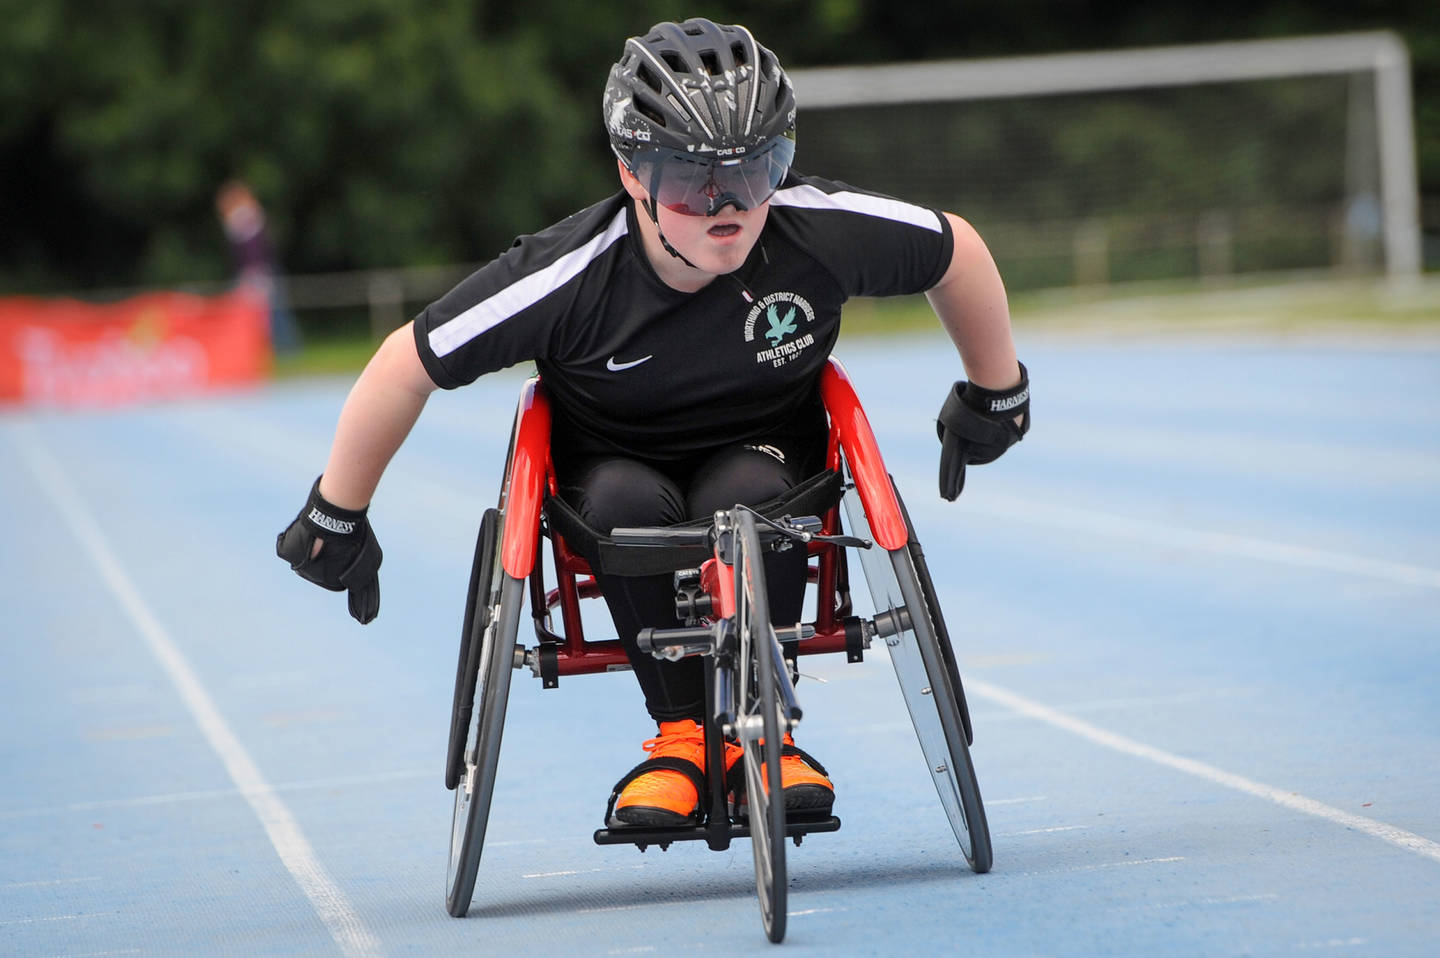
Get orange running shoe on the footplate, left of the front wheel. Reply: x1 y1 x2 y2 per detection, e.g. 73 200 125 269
605 719 740 828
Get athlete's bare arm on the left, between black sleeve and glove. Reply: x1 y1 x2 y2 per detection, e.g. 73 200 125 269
320 323 436 509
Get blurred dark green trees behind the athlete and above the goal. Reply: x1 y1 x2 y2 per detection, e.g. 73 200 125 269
0 0 1440 292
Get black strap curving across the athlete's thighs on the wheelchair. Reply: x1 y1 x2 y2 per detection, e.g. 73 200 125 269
544 470 841 576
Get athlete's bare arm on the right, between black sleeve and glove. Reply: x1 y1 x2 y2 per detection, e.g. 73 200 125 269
924 213 1020 389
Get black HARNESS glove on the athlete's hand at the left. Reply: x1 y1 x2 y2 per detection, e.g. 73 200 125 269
275 478 383 625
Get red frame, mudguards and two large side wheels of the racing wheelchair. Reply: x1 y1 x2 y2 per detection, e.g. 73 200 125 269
446 352 992 916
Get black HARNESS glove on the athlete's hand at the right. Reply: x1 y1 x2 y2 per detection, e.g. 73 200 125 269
935 363 1030 501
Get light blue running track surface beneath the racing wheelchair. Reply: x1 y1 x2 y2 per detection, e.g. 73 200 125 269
0 330 1440 958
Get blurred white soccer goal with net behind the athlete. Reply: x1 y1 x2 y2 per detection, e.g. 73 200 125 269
791 32 1421 287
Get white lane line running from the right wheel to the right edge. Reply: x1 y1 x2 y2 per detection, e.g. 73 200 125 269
965 679 1440 861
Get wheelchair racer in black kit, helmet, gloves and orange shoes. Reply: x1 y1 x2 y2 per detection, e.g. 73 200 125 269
276 19 1030 827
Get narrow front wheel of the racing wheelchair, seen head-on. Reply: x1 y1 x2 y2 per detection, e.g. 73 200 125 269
733 510 788 942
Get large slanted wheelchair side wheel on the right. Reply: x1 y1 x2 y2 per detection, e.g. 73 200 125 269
844 488 994 872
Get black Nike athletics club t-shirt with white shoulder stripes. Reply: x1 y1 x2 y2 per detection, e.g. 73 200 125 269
415 173 953 461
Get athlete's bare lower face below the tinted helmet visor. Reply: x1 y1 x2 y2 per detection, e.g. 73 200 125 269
619 157 770 285
